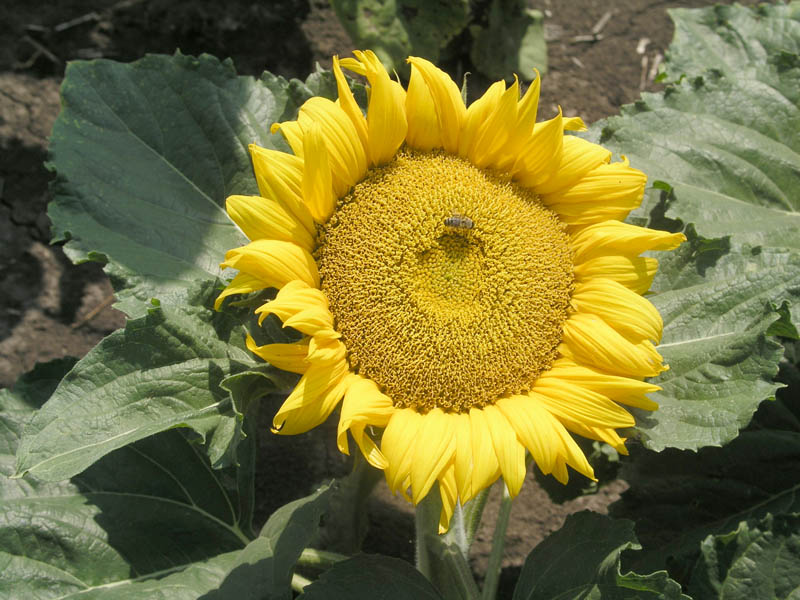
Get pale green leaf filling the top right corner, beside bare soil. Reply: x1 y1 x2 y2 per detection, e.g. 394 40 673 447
665 2 800 78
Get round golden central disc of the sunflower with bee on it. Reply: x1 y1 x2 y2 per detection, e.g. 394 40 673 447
315 150 573 412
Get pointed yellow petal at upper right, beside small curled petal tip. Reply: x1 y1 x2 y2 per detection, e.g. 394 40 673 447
512 108 564 189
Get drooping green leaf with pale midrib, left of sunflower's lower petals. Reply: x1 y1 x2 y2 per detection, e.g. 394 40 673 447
17 282 286 481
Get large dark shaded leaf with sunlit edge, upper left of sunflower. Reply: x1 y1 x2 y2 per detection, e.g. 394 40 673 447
48 54 335 316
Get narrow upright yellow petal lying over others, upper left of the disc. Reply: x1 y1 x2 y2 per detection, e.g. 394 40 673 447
303 122 336 224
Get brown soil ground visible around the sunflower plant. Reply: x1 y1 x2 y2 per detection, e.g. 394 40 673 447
0 0 754 597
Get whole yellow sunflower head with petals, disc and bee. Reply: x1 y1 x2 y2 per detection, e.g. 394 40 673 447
217 51 685 530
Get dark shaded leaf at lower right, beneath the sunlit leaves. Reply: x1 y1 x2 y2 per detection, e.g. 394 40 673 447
611 354 800 580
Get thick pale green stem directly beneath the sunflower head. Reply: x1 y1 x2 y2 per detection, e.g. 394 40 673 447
415 488 480 600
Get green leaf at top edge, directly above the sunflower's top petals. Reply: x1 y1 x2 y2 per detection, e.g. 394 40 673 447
331 0 470 75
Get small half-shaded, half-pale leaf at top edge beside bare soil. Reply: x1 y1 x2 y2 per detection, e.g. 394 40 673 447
470 0 547 81
